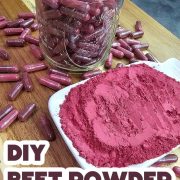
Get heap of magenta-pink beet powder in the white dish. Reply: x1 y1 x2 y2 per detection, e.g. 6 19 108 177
60 65 180 167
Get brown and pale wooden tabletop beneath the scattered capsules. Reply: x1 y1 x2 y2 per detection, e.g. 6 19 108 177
0 0 180 177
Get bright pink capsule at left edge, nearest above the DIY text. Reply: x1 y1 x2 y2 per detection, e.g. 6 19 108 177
0 109 19 132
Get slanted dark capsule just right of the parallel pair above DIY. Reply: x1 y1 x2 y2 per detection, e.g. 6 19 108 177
18 103 36 122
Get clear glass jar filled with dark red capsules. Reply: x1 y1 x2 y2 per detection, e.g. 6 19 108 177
36 0 123 72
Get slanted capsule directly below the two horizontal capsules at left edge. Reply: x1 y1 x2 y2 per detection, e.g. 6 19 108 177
8 81 24 101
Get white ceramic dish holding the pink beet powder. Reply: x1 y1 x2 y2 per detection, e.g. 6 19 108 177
49 59 180 169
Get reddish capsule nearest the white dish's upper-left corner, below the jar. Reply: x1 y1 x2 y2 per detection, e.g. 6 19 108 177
38 77 62 91
